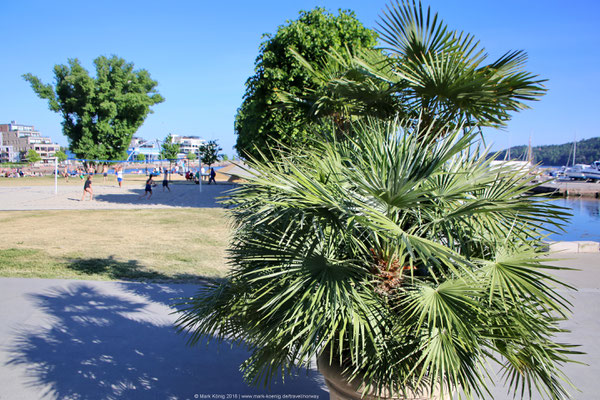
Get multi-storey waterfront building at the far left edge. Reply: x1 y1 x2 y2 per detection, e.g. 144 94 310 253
0 121 60 163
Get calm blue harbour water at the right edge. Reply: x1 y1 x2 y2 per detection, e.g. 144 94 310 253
549 199 600 242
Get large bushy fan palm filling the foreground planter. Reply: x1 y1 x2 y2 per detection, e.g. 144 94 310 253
178 119 573 399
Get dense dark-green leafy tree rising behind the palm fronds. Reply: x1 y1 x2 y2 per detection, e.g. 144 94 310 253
235 8 376 156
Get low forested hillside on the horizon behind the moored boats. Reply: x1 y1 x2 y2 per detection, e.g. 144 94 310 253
497 137 600 166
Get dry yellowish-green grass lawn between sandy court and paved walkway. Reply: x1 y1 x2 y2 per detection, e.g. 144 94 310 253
0 208 230 281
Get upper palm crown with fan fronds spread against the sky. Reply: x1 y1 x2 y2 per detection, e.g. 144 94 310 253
280 0 545 139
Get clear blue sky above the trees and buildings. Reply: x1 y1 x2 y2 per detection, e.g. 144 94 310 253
0 0 600 154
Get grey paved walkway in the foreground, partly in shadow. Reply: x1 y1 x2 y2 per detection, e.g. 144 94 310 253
0 253 600 400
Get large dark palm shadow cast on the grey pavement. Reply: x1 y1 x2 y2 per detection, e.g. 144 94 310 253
5 282 327 399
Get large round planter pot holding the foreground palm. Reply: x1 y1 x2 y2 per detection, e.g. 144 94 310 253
317 354 452 400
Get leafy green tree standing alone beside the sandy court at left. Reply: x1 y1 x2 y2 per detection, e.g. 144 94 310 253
23 56 164 164
